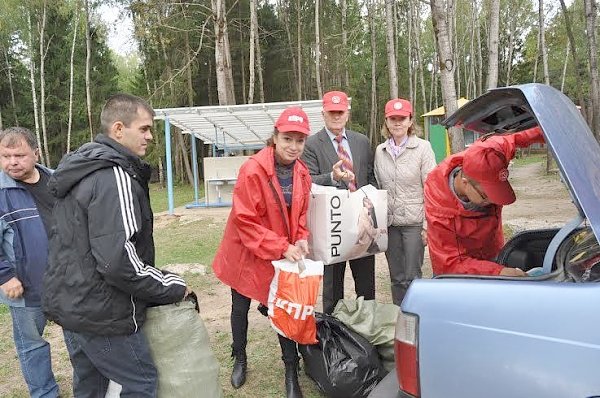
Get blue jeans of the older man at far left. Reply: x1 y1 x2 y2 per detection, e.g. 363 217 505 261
9 307 58 398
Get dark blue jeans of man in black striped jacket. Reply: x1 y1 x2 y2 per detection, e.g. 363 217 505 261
64 330 158 398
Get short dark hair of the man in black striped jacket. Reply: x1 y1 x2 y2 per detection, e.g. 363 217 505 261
100 93 156 134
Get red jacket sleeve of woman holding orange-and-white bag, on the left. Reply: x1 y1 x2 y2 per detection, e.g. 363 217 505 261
231 168 289 260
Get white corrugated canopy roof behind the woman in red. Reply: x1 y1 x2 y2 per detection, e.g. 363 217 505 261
155 100 324 149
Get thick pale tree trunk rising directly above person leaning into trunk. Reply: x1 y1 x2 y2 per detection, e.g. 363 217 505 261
430 0 465 153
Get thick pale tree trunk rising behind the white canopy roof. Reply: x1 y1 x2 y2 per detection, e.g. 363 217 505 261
211 0 235 105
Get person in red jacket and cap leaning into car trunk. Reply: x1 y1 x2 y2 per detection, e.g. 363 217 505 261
424 127 544 276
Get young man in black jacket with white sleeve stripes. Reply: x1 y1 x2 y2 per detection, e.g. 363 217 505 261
43 94 190 398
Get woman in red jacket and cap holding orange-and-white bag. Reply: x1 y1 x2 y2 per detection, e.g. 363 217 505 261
213 107 311 398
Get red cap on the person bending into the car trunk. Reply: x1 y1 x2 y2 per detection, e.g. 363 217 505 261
462 141 516 205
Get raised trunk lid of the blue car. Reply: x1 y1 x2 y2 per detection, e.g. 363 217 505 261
442 83 600 243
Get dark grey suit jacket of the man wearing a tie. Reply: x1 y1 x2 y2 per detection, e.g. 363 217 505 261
302 129 377 189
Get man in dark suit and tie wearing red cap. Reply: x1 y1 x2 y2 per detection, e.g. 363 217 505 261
302 91 377 314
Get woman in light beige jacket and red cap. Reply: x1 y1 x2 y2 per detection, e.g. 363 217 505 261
375 98 436 306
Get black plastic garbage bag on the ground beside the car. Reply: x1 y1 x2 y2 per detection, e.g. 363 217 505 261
299 313 386 398
